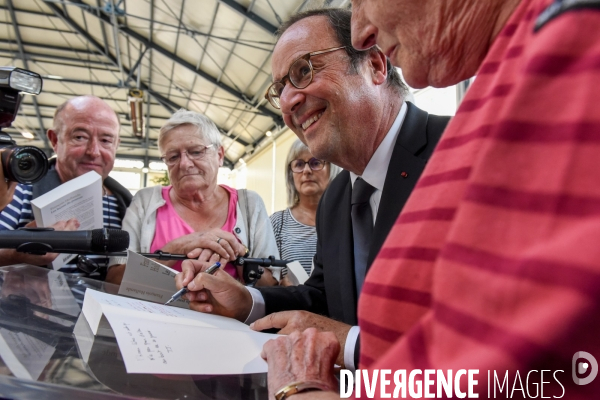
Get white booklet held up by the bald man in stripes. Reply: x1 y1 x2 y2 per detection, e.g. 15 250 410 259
31 171 104 270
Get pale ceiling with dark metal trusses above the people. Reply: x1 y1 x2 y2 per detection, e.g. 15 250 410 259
0 0 349 166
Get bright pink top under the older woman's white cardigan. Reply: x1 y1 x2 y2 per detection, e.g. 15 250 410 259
150 185 238 278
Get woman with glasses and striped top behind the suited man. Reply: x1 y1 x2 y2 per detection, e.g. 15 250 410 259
271 139 340 275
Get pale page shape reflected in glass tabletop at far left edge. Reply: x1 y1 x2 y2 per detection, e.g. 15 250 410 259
0 328 55 381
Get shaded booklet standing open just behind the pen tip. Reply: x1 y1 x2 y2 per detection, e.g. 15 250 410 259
119 250 189 308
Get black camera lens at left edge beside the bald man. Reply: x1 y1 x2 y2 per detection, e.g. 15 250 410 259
2 146 48 184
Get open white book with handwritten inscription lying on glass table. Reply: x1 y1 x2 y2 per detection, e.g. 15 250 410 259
82 289 277 375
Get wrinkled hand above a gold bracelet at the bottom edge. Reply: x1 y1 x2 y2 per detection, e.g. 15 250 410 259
261 328 340 399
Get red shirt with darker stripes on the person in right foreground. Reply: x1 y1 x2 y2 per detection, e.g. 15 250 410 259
358 0 600 399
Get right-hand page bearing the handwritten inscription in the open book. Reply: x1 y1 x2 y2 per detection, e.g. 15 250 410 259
107 314 270 375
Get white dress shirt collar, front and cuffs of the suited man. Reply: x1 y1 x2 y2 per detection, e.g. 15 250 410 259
244 103 408 370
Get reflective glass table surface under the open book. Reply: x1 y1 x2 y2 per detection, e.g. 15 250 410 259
0 265 268 400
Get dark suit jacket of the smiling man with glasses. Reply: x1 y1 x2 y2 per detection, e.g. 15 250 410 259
259 102 450 325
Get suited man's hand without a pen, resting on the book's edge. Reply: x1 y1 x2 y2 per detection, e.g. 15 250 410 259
250 311 352 367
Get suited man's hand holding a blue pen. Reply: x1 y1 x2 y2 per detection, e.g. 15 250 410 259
175 260 252 321
